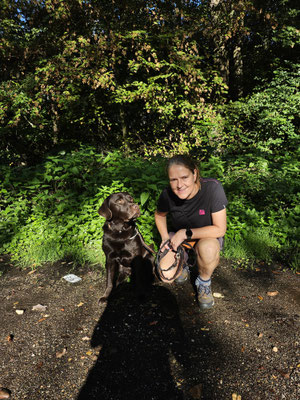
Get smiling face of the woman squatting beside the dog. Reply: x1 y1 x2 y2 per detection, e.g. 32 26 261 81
168 164 199 200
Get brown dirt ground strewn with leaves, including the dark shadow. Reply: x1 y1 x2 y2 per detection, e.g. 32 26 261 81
0 258 300 400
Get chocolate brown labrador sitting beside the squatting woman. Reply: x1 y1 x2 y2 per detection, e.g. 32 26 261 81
98 192 154 302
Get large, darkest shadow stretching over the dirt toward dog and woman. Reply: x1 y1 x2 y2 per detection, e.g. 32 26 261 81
77 284 189 400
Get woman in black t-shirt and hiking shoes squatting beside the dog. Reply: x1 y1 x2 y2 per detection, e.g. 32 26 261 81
155 155 228 310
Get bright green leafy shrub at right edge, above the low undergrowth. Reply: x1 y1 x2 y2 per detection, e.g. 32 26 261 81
225 64 300 155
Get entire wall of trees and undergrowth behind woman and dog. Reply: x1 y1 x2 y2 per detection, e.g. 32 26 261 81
0 0 300 270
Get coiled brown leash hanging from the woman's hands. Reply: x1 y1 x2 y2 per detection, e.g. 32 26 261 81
155 239 195 282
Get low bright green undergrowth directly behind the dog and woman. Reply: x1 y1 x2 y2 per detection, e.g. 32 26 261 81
0 147 299 270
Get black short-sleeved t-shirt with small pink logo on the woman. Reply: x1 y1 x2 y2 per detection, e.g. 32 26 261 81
157 178 228 232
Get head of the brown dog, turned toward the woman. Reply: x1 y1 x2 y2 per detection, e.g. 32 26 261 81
98 192 141 222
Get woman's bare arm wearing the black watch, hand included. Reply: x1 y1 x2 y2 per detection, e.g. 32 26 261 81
171 208 227 250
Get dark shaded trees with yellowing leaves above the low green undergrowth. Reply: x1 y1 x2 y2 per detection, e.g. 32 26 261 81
0 0 299 165
